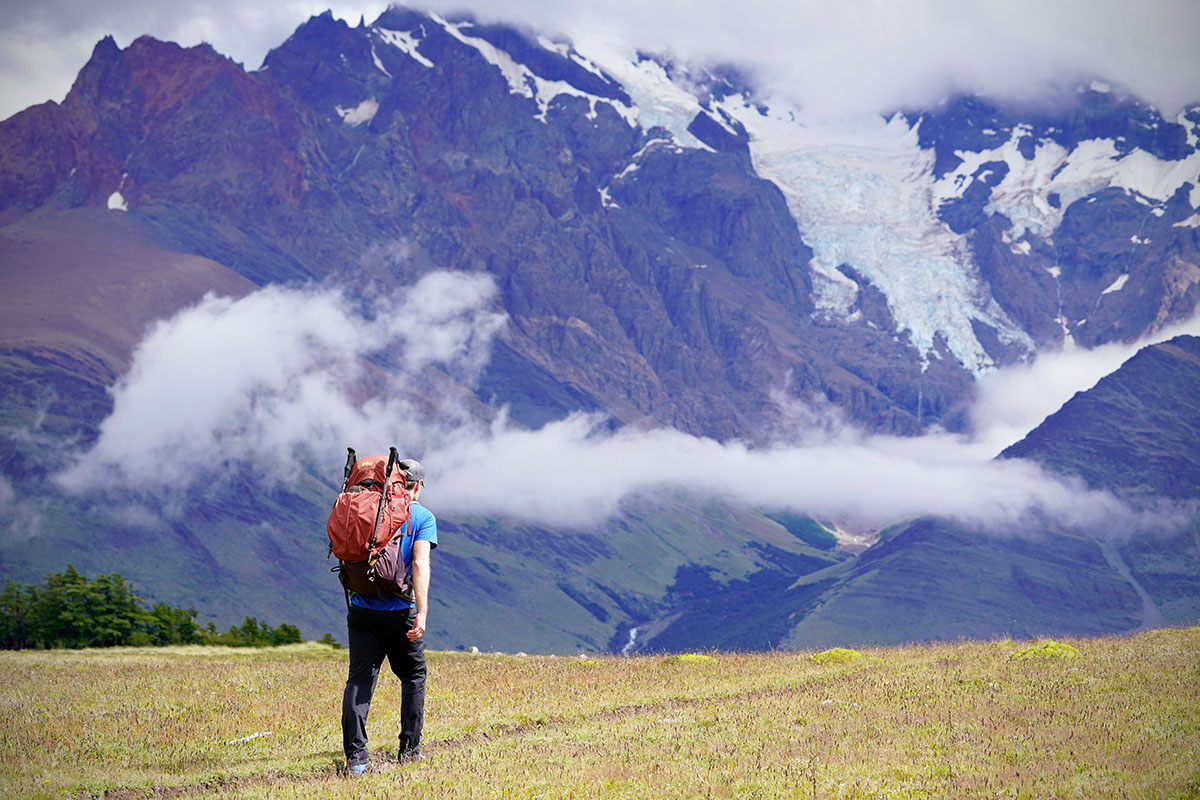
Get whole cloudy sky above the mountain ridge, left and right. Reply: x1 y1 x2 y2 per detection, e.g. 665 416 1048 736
0 0 1200 119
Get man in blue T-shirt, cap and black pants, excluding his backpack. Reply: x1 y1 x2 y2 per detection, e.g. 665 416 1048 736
342 458 438 775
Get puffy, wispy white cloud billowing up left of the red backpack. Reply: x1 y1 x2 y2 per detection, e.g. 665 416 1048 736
64 272 505 489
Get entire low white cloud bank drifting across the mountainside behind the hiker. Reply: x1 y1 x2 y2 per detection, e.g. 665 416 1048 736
56 272 1196 537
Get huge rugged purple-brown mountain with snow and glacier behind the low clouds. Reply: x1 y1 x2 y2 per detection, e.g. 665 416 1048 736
0 7 1200 650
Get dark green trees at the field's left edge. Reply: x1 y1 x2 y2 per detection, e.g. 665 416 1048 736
0 565 307 650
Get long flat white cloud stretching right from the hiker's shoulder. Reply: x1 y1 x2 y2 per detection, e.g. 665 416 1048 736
426 407 1128 529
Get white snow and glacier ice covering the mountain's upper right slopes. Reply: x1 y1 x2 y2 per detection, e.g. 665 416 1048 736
443 20 1200 374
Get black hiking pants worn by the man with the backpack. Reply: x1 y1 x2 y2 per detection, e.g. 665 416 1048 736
342 604 425 764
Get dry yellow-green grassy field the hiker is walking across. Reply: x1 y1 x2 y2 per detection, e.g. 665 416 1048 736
0 627 1200 800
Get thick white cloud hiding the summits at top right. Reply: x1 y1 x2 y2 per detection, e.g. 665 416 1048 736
428 0 1200 115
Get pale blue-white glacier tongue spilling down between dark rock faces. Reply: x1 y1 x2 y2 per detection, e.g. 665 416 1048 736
720 96 1034 374
